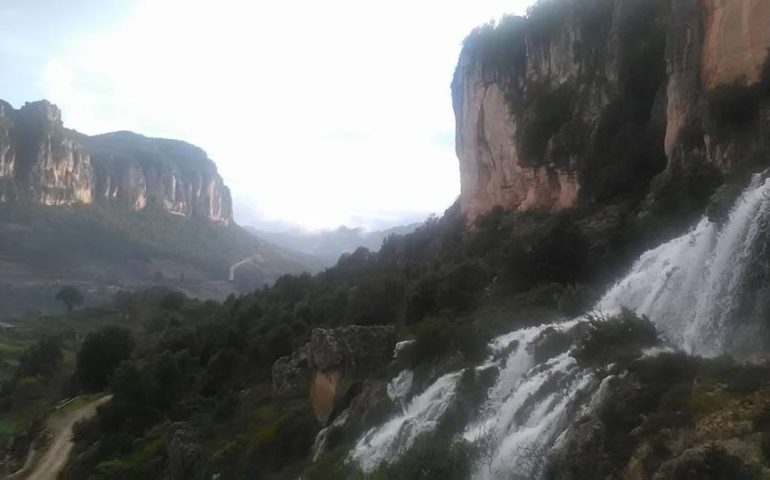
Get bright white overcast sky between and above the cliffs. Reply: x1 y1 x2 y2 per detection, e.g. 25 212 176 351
0 0 531 229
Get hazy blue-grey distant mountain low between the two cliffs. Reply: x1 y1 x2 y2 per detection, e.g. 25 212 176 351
246 223 421 265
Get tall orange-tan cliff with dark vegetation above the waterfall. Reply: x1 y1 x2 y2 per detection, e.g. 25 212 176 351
452 0 770 220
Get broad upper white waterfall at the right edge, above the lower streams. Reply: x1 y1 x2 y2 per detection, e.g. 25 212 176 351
597 175 770 356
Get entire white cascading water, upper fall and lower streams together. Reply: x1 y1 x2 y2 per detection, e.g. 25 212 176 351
350 175 770 480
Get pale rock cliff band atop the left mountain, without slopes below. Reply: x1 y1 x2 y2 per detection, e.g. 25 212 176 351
0 101 232 224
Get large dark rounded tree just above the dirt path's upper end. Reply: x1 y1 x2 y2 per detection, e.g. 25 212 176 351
76 325 134 391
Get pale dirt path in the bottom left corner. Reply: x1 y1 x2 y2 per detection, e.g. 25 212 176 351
8 395 112 480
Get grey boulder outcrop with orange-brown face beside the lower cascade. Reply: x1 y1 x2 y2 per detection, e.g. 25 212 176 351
273 325 396 425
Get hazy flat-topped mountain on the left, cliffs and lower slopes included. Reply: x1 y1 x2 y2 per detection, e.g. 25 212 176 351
0 101 321 316
